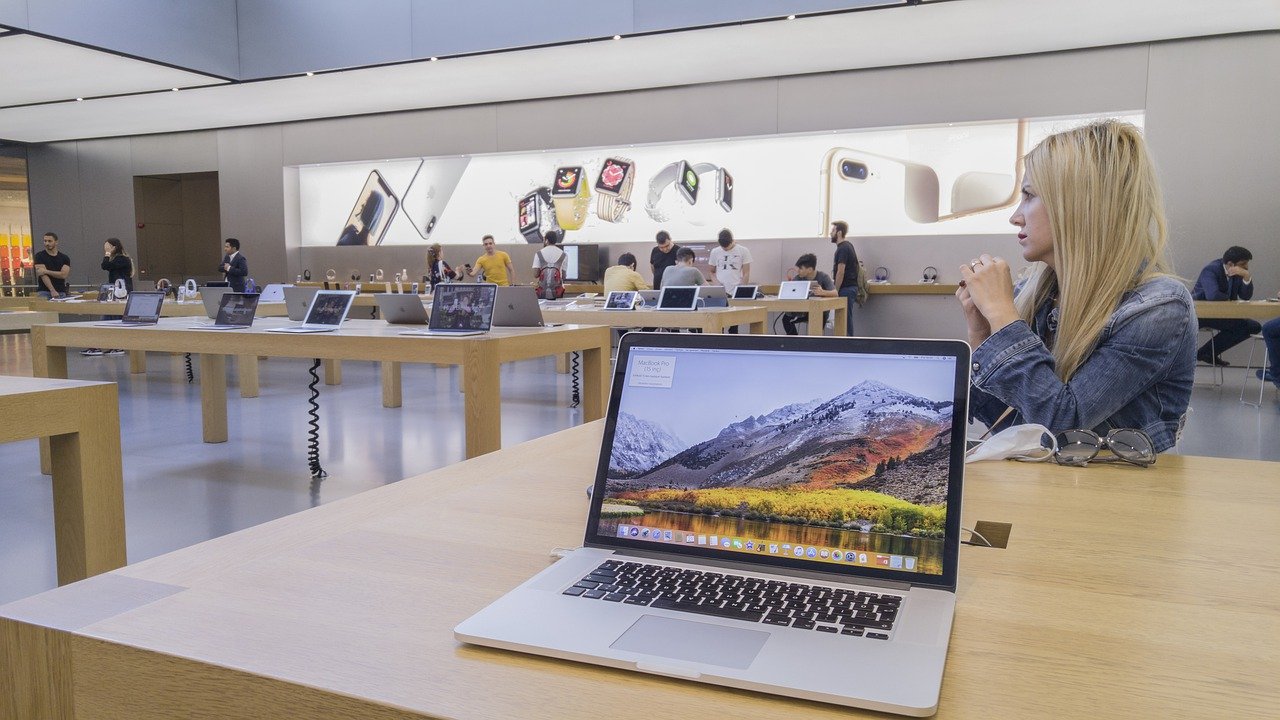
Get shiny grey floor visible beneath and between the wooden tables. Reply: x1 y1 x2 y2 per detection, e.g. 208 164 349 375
0 334 1280 603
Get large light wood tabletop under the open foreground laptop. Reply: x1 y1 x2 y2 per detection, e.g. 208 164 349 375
0 423 1280 720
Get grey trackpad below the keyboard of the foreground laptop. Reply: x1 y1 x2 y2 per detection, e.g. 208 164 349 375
609 615 769 670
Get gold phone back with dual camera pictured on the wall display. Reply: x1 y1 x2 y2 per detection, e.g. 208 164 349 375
819 147 938 234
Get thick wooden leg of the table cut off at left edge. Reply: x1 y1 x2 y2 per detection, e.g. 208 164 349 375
50 386 127 585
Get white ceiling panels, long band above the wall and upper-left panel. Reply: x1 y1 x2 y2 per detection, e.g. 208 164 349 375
0 0 1280 142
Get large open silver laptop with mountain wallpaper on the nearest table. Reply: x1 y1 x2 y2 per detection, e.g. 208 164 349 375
454 333 969 716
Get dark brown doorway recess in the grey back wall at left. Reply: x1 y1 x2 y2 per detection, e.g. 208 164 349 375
133 173 223 284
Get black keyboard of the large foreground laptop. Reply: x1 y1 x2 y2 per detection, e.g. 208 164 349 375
564 560 902 641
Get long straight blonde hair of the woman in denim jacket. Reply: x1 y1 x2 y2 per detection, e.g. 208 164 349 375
1016 120 1170 382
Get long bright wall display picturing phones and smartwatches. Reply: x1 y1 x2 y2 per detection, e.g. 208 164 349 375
297 113 1143 246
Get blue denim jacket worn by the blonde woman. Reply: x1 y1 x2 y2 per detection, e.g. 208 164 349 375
969 271 1196 452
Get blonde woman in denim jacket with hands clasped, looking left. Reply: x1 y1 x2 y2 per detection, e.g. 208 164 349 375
956 120 1196 452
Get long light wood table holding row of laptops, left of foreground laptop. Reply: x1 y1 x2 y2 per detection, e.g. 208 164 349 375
31 318 609 457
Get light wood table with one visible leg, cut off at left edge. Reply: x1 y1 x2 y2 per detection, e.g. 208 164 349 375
0 375 125 586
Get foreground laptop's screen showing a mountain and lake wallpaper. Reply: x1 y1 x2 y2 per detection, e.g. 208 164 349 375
588 333 968 584
